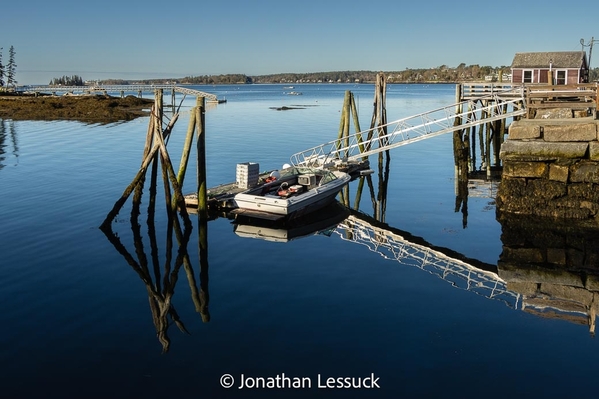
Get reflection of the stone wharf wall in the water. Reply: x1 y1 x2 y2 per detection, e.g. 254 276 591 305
498 215 599 336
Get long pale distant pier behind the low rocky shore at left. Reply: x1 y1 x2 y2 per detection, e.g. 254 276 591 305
18 84 217 101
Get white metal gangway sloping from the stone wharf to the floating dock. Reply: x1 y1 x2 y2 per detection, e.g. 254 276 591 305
290 86 526 166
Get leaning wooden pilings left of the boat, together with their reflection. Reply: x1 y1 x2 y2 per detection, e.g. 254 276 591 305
100 89 210 352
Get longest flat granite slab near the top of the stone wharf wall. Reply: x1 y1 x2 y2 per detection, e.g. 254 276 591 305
499 140 589 161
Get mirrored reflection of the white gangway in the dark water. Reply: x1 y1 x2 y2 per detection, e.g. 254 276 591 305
334 213 521 309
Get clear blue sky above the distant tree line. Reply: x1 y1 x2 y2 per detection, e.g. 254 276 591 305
0 0 599 84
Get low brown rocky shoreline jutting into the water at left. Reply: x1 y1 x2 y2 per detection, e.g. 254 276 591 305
0 93 154 124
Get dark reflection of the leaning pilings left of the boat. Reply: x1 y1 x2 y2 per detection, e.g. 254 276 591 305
100 198 210 353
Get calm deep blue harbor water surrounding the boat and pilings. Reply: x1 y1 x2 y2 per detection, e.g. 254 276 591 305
0 84 599 398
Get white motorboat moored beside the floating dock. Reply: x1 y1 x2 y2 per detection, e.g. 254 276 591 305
233 167 351 219
